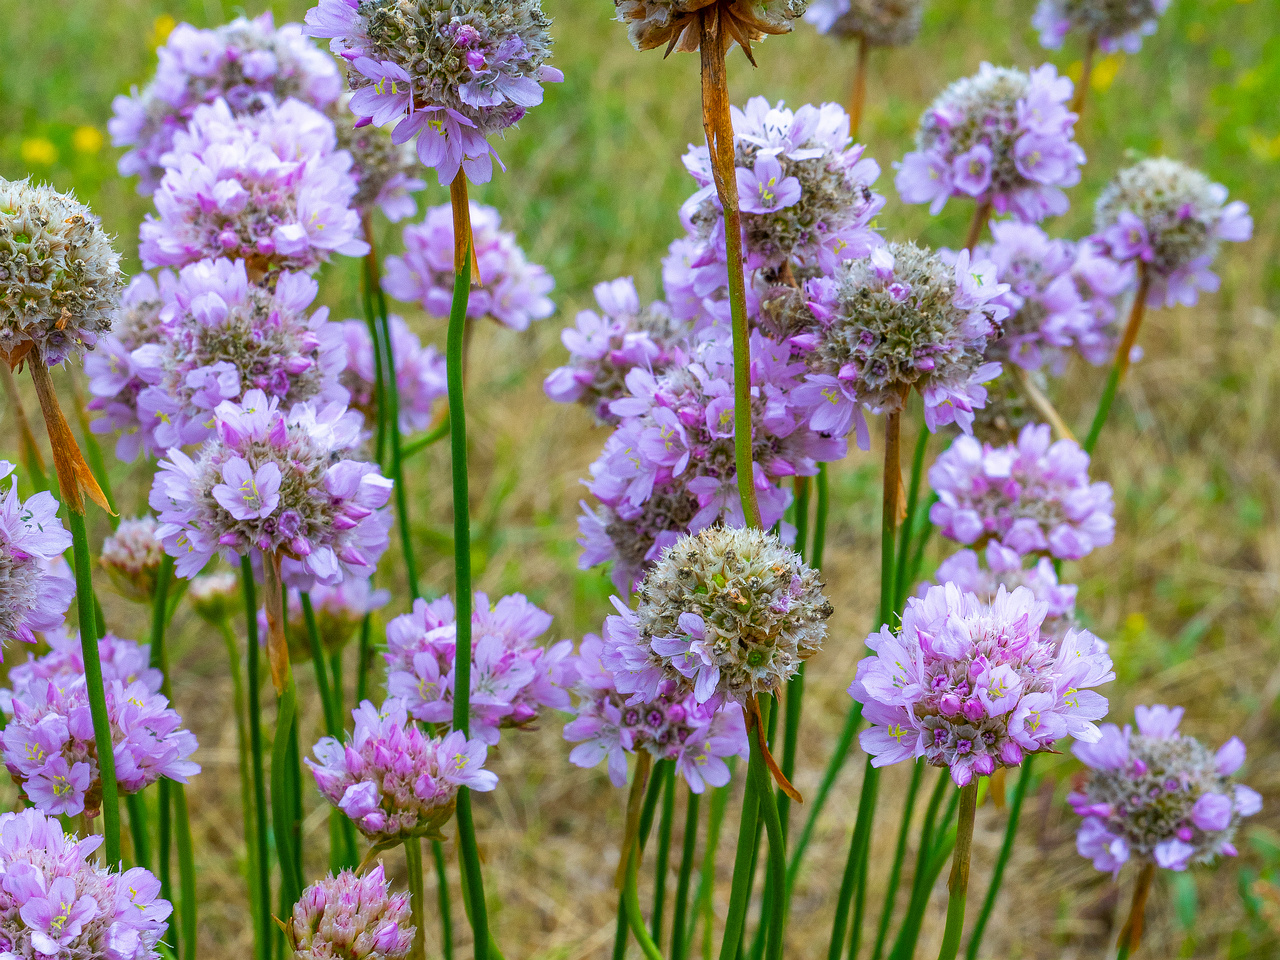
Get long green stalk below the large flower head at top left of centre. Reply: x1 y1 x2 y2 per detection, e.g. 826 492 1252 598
448 173 489 960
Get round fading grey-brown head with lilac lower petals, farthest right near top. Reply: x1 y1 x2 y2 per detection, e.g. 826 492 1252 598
1094 156 1253 306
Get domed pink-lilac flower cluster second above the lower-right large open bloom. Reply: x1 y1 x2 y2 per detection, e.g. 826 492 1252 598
929 424 1116 559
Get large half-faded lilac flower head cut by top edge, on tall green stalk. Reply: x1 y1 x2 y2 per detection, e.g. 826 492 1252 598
306 0 564 184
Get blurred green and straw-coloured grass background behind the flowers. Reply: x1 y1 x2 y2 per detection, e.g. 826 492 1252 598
0 0 1280 960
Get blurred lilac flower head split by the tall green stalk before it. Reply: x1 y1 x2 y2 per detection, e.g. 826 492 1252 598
383 202 556 330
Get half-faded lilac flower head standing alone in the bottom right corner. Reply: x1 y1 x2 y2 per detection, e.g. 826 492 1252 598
1068 705 1262 873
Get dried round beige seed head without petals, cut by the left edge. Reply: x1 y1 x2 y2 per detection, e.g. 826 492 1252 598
0 178 124 366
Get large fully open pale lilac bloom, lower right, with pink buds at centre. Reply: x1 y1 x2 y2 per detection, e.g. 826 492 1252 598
849 584 1115 786
